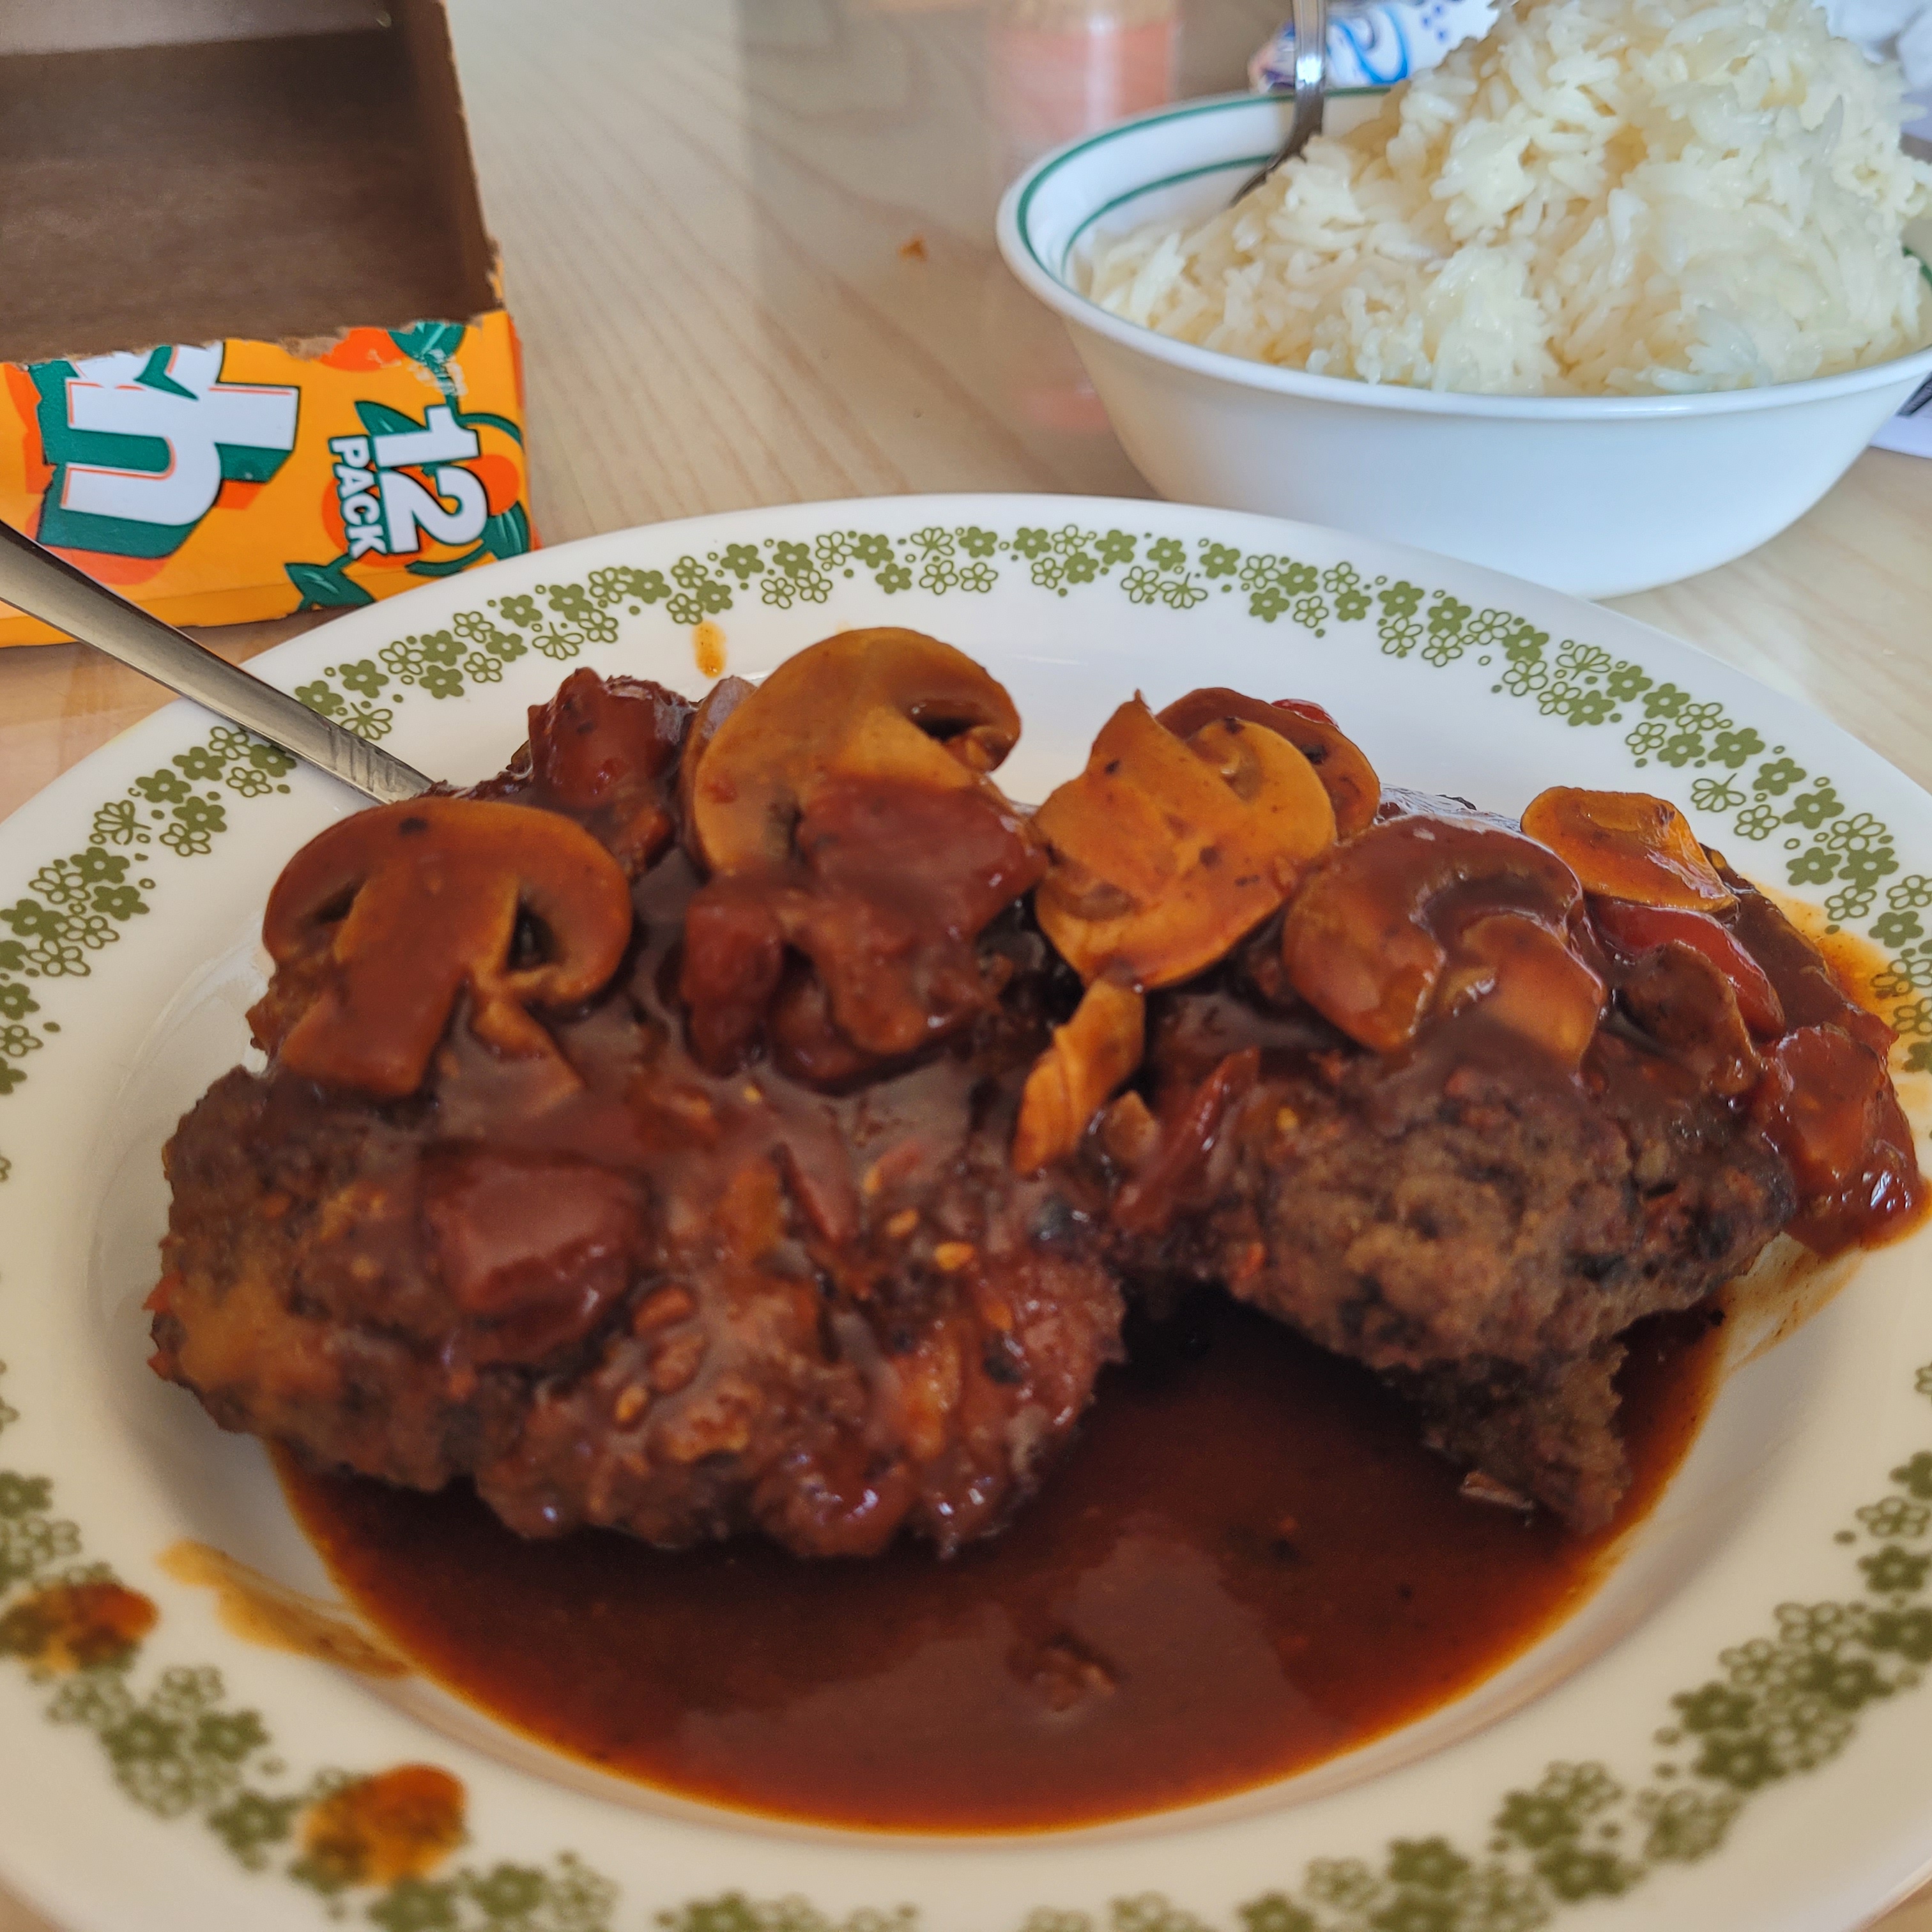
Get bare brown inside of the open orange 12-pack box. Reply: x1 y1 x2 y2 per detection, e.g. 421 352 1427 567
0 0 496 361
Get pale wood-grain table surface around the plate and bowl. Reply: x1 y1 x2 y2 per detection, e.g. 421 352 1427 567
0 0 1932 1932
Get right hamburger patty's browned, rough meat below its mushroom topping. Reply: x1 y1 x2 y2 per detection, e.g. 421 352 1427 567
1124 946 1797 1528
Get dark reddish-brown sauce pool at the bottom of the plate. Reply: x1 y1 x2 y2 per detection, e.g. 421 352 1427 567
278 1296 1721 1832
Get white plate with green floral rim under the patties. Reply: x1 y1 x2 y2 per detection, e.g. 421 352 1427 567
0 496 1932 1932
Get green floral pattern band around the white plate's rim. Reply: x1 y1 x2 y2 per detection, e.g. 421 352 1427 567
0 524 1932 1932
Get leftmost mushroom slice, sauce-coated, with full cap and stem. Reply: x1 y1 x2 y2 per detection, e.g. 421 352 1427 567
263 798 632 1100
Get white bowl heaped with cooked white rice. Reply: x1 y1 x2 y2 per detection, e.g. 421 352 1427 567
999 0 1932 597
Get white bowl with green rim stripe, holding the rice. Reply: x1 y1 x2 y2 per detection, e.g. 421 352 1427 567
999 95 1932 597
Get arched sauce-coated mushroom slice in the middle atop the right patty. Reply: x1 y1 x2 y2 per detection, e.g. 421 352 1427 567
1281 813 1583 1053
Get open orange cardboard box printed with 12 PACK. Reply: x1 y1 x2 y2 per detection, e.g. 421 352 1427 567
0 0 535 643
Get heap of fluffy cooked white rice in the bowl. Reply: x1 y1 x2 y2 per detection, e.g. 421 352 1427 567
1084 0 1932 396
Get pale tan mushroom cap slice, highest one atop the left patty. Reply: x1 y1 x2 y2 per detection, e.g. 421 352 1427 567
686 630 1020 873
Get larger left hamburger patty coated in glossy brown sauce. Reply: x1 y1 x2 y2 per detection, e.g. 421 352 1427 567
153 657 1121 1555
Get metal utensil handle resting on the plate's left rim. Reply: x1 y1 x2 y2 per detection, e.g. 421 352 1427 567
0 524 431 806
